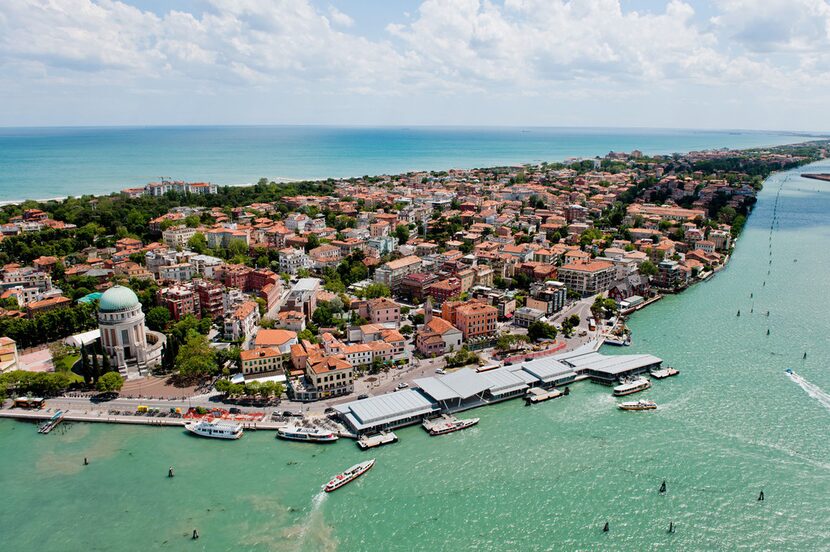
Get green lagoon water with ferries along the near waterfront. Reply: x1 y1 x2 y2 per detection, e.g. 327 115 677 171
0 128 830 552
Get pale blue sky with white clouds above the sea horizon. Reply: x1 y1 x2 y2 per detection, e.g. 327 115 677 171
0 0 830 132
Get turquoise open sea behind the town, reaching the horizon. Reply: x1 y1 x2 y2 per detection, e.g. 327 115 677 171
0 126 820 201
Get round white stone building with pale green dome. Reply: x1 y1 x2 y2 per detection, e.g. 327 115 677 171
98 286 165 379
